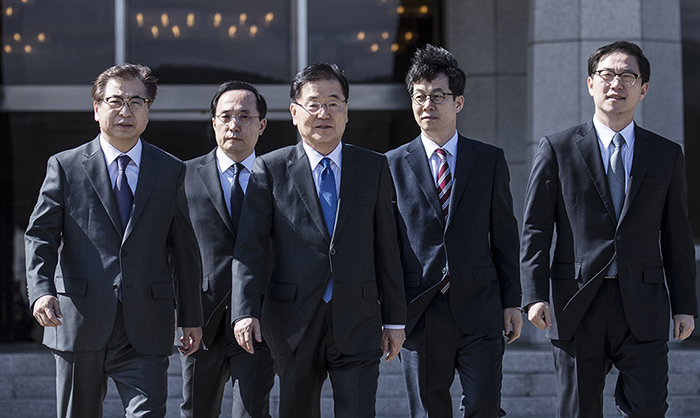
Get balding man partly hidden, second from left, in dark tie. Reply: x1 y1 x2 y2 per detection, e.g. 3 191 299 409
180 81 275 418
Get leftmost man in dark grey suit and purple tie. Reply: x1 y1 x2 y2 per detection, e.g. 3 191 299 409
25 64 202 418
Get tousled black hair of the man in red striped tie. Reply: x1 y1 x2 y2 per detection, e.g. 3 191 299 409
406 44 467 98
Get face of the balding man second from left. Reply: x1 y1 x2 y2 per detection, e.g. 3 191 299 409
211 90 267 163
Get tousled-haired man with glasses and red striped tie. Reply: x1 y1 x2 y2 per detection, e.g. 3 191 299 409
387 45 523 418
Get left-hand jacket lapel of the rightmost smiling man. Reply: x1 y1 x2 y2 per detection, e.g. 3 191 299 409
575 120 617 222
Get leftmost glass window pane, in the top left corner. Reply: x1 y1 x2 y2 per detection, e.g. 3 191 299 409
2 0 114 85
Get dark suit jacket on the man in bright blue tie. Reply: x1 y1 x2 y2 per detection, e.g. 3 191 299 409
231 142 406 354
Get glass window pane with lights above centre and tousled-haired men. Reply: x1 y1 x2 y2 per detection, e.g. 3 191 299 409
308 0 440 83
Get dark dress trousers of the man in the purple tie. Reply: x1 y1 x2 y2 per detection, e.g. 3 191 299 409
52 303 168 418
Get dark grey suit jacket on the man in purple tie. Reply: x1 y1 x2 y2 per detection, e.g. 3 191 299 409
25 137 202 356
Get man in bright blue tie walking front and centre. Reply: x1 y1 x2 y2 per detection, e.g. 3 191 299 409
231 64 406 418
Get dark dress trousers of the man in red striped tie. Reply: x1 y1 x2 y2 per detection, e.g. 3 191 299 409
401 294 505 418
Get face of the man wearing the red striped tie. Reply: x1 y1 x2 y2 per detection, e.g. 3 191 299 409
411 74 464 146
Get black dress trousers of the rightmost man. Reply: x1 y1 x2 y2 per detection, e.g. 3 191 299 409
552 279 668 418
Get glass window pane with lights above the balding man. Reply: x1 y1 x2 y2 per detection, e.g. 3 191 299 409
126 0 293 84
